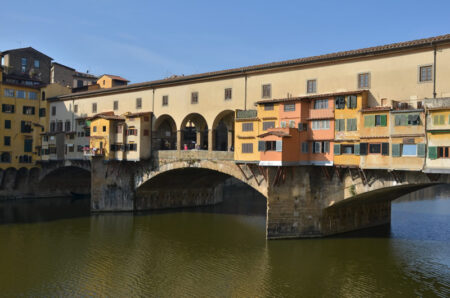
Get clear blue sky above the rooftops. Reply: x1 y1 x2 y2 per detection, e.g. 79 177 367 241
0 0 450 83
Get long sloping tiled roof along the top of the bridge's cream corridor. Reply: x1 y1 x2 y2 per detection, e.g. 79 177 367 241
52 34 450 100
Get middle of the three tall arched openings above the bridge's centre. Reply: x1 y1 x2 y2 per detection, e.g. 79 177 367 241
181 113 208 150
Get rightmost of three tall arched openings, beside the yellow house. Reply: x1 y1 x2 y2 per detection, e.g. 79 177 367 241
213 110 234 151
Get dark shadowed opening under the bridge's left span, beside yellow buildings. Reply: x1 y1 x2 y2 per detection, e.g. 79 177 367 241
37 166 91 196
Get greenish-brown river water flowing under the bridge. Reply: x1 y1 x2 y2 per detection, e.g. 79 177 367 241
0 185 450 297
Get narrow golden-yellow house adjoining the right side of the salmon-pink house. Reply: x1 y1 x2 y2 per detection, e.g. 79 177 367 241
333 90 368 167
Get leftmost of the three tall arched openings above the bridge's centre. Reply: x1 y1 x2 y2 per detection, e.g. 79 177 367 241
152 115 177 150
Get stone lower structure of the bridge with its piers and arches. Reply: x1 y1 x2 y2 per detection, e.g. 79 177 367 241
87 150 450 239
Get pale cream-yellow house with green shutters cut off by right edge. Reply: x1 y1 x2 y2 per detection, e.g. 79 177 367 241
425 98 450 174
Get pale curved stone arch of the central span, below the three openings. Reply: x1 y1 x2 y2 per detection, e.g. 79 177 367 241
134 160 268 199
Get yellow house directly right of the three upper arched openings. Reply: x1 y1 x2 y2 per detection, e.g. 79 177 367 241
234 110 260 163
